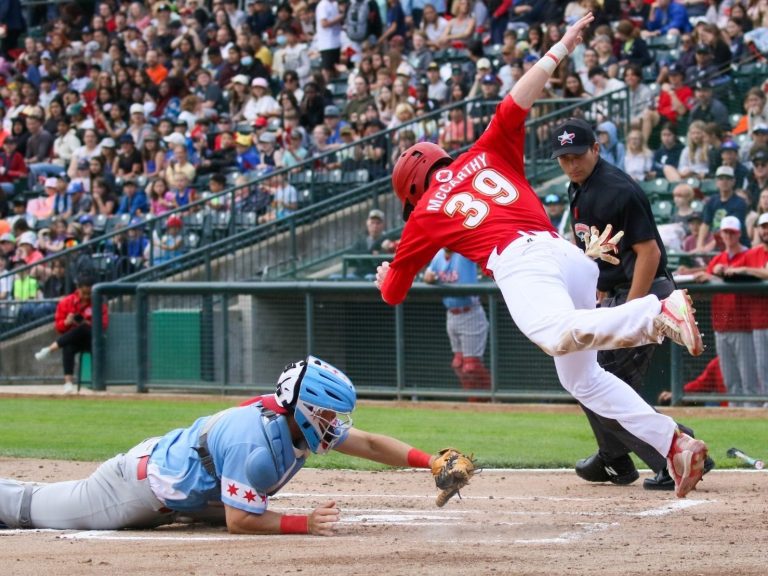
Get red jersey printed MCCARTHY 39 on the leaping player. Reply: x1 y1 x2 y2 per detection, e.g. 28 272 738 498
381 96 555 305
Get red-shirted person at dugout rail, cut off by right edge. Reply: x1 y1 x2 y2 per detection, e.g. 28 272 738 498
725 213 768 407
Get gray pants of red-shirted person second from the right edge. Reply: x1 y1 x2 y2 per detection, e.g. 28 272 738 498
715 332 765 407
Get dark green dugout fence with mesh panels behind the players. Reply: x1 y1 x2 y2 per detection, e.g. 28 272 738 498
84 282 768 403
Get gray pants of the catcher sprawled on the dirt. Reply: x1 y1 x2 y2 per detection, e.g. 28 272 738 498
0 439 175 530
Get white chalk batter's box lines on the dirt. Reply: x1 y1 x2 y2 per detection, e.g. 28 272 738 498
0 494 717 545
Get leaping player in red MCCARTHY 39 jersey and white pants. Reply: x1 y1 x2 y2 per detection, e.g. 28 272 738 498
376 14 707 497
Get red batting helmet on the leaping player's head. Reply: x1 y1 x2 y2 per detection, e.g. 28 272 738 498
392 142 453 220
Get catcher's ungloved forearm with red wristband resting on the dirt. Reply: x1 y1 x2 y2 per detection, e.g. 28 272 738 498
224 502 339 536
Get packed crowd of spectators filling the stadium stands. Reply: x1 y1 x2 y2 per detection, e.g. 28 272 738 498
0 0 768 328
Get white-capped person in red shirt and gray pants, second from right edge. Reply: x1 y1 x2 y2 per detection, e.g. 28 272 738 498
694 216 761 407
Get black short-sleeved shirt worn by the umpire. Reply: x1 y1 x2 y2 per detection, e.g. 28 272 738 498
568 158 667 292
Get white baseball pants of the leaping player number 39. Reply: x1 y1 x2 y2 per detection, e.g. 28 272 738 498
488 232 676 457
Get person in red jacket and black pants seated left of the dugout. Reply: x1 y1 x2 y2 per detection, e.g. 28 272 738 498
35 275 109 394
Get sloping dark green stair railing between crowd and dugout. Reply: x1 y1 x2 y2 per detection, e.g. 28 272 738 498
0 90 627 340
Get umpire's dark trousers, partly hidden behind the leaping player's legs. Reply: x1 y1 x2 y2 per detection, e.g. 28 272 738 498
581 278 693 472
